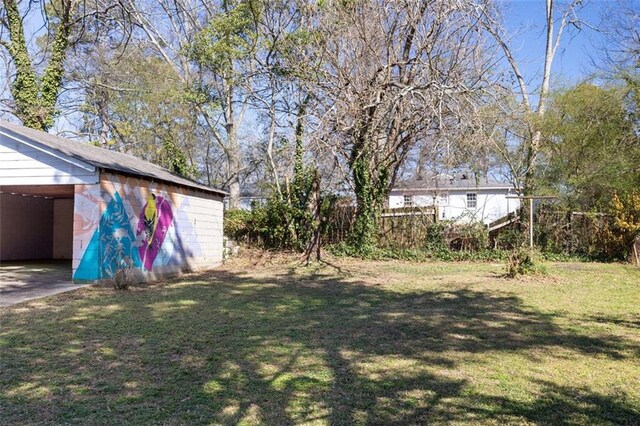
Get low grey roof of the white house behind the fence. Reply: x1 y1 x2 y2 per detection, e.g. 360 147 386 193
391 173 515 192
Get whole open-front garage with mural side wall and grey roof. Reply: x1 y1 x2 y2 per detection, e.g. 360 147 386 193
0 120 226 282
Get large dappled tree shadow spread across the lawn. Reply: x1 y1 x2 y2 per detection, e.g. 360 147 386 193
0 271 637 425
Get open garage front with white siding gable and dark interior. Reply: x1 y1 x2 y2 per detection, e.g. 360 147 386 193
0 128 99 290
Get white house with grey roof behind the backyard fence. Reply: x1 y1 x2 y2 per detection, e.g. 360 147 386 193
389 173 520 224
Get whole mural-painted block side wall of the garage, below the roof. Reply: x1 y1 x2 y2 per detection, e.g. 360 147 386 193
74 173 223 280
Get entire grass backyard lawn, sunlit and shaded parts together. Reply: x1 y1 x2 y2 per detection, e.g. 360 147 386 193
0 258 640 425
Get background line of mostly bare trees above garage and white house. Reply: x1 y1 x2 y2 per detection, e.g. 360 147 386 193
0 0 640 255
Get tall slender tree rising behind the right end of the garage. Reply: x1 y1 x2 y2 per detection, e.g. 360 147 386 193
108 0 260 208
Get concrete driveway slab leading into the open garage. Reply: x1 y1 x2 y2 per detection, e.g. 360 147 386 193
0 261 88 308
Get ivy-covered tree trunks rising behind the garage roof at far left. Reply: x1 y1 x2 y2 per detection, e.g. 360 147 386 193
0 0 127 130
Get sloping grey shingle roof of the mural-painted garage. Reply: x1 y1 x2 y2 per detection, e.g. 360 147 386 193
0 120 227 196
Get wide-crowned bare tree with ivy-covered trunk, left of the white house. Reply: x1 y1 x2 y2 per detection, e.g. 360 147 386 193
310 0 490 250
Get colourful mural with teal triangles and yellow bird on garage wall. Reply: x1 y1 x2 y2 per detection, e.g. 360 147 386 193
73 176 202 280
